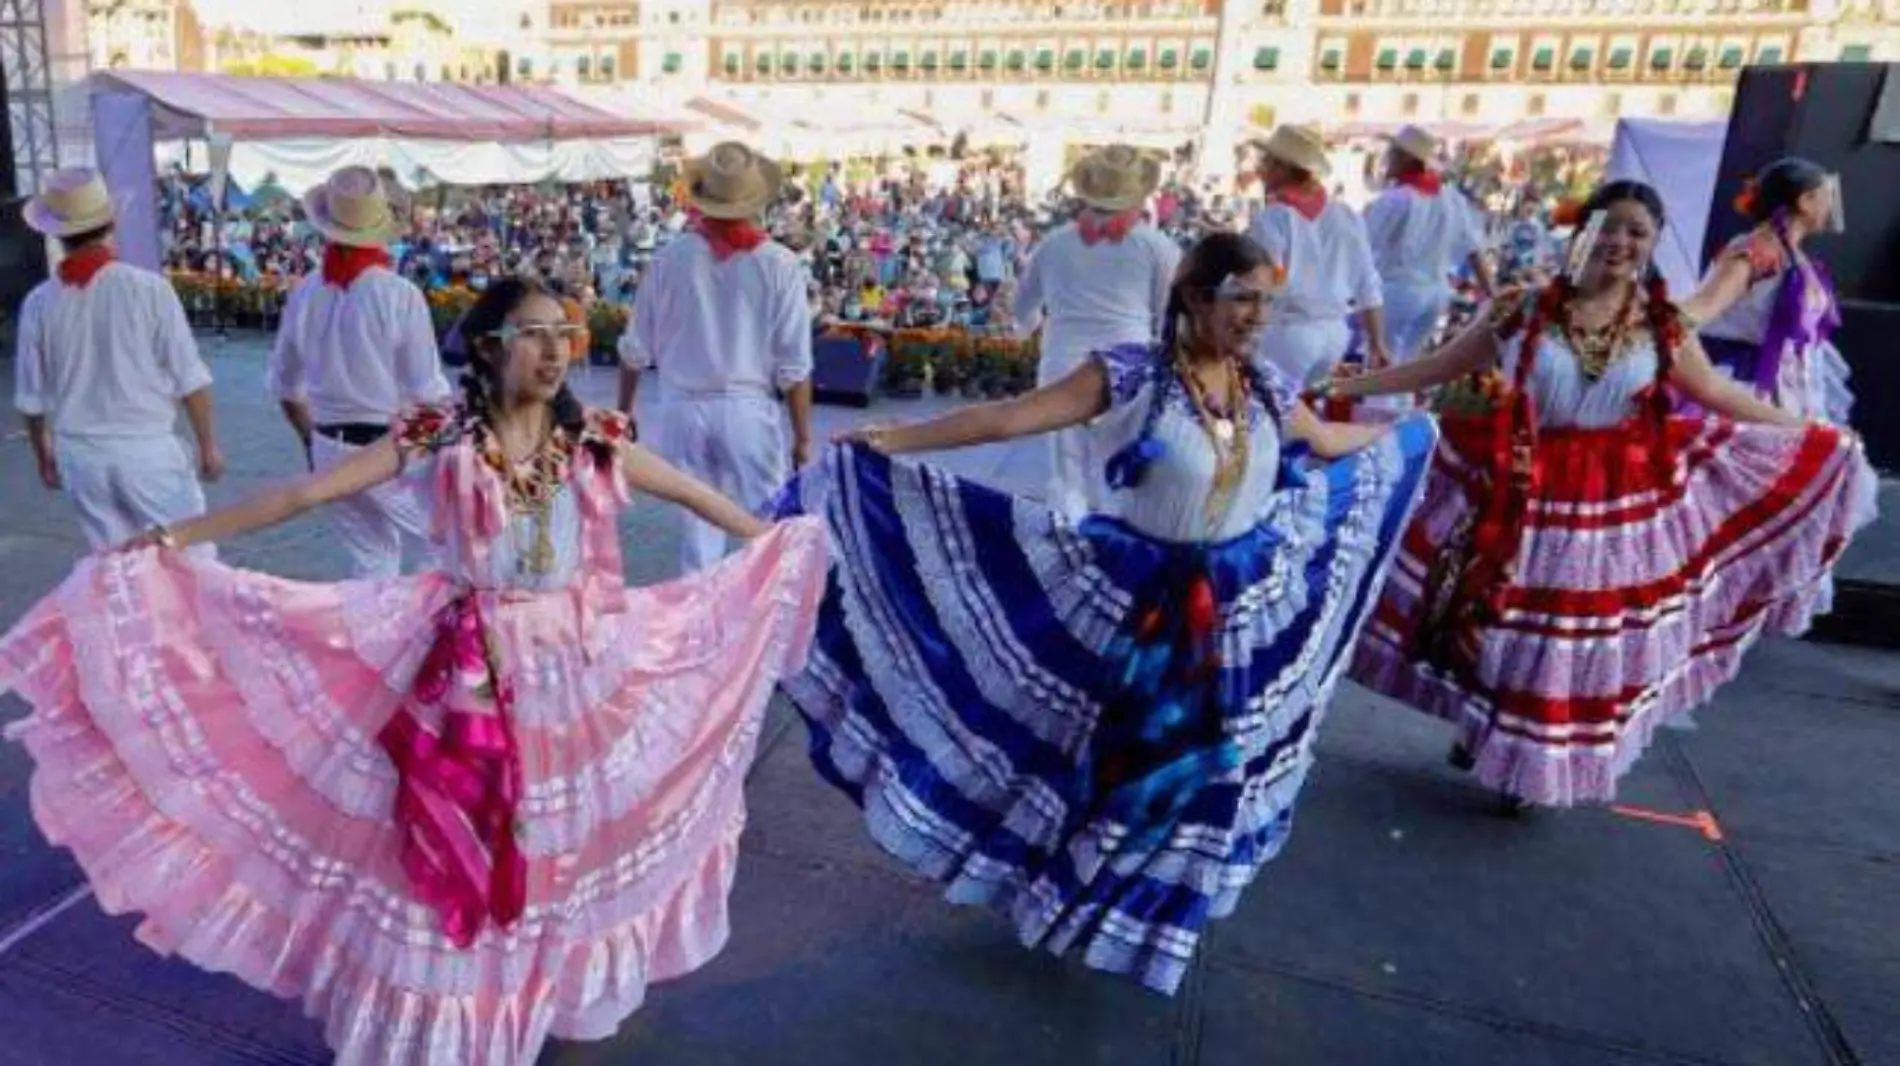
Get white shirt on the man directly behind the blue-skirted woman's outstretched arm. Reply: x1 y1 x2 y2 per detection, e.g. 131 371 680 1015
1013 222 1182 359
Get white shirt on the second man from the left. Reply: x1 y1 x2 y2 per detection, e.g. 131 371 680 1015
266 266 450 426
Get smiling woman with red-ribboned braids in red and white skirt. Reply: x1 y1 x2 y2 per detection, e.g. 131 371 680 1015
1330 182 1875 806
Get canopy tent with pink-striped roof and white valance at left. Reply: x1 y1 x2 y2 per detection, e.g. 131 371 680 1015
89 70 680 270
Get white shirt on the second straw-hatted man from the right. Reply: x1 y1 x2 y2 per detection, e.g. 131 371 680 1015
1248 200 1385 323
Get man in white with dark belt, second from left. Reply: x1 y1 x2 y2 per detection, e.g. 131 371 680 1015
268 167 452 578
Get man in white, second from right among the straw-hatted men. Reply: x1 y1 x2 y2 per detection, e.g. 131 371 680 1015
1248 125 1387 388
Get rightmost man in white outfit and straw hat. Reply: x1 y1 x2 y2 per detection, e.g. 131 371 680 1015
1366 125 1492 363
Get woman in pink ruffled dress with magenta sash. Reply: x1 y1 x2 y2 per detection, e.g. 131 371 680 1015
0 279 827 1066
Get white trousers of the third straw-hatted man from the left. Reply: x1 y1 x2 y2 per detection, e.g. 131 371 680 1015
654 390 792 574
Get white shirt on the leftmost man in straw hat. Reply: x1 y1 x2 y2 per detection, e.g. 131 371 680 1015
13 262 211 439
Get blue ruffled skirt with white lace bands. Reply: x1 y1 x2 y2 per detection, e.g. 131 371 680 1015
775 416 1436 994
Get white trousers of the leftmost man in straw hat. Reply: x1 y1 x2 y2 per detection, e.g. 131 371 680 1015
53 435 217 559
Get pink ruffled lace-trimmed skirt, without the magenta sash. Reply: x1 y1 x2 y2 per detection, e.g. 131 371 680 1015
0 519 827 1066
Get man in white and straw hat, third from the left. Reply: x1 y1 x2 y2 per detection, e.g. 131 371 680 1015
619 143 811 572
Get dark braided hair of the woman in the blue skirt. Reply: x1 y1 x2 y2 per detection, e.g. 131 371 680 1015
1108 232 1286 488
